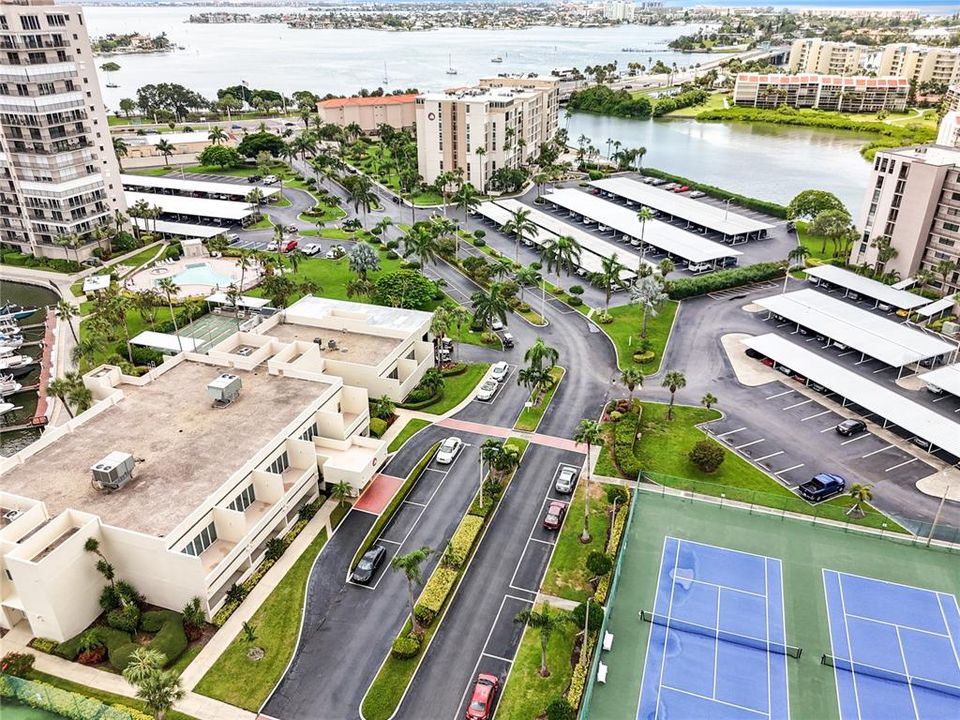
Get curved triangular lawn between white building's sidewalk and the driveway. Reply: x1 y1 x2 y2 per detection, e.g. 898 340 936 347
195 529 327 712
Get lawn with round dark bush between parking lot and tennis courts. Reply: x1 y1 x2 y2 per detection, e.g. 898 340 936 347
597 402 903 531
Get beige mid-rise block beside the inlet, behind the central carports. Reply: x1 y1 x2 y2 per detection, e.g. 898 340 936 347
417 77 560 190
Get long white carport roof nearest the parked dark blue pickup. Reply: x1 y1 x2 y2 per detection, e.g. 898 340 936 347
744 333 960 457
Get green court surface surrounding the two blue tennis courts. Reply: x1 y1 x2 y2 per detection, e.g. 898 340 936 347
582 490 960 720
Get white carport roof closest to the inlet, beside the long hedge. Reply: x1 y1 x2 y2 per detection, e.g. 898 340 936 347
590 177 773 235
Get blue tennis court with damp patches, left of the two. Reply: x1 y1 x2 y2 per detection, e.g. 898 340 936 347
637 537 789 720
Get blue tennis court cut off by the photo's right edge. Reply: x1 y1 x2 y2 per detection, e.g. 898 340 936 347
823 570 960 720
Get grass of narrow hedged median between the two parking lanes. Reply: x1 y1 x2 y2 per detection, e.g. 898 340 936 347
360 437 529 720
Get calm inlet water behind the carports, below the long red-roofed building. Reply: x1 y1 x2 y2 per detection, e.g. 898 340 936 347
567 113 870 208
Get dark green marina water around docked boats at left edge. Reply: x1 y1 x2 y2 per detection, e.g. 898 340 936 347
0 280 58 456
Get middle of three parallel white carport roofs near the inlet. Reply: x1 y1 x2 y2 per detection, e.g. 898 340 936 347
543 188 743 263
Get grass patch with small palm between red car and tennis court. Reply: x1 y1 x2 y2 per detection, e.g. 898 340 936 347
497 606 579 720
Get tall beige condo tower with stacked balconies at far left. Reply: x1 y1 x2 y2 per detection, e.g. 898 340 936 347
0 0 126 259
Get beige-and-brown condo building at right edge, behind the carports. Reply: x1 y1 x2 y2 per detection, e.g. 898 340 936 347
850 145 960 293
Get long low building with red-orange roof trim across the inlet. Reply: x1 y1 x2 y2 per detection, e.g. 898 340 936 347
733 73 910 112
